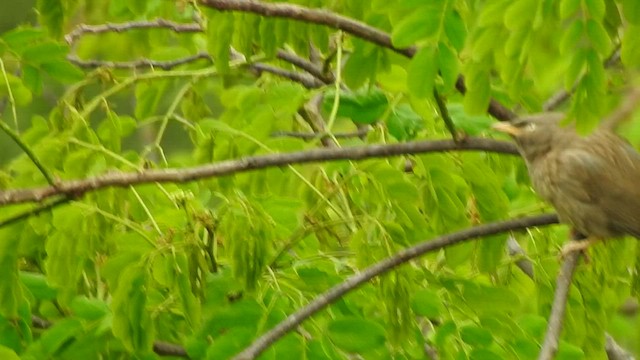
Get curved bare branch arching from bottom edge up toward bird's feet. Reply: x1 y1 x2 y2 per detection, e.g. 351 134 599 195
234 214 558 360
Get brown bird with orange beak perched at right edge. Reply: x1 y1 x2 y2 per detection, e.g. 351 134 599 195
494 111 640 254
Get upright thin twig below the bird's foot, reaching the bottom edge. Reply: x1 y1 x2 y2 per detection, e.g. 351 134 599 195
538 251 581 360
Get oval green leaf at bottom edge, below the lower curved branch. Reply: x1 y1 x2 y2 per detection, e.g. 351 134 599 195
327 317 386 353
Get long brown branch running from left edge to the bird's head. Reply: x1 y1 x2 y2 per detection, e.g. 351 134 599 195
0 138 518 205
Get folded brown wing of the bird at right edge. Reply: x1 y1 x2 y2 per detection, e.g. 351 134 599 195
557 143 640 238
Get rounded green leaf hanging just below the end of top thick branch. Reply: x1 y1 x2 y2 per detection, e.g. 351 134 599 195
407 46 438 98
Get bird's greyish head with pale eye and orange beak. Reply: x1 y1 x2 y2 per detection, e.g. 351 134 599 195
493 113 578 162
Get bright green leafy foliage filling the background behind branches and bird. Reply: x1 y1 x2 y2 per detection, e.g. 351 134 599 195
0 0 640 359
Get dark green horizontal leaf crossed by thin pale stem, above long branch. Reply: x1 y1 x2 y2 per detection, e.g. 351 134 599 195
322 88 389 124
